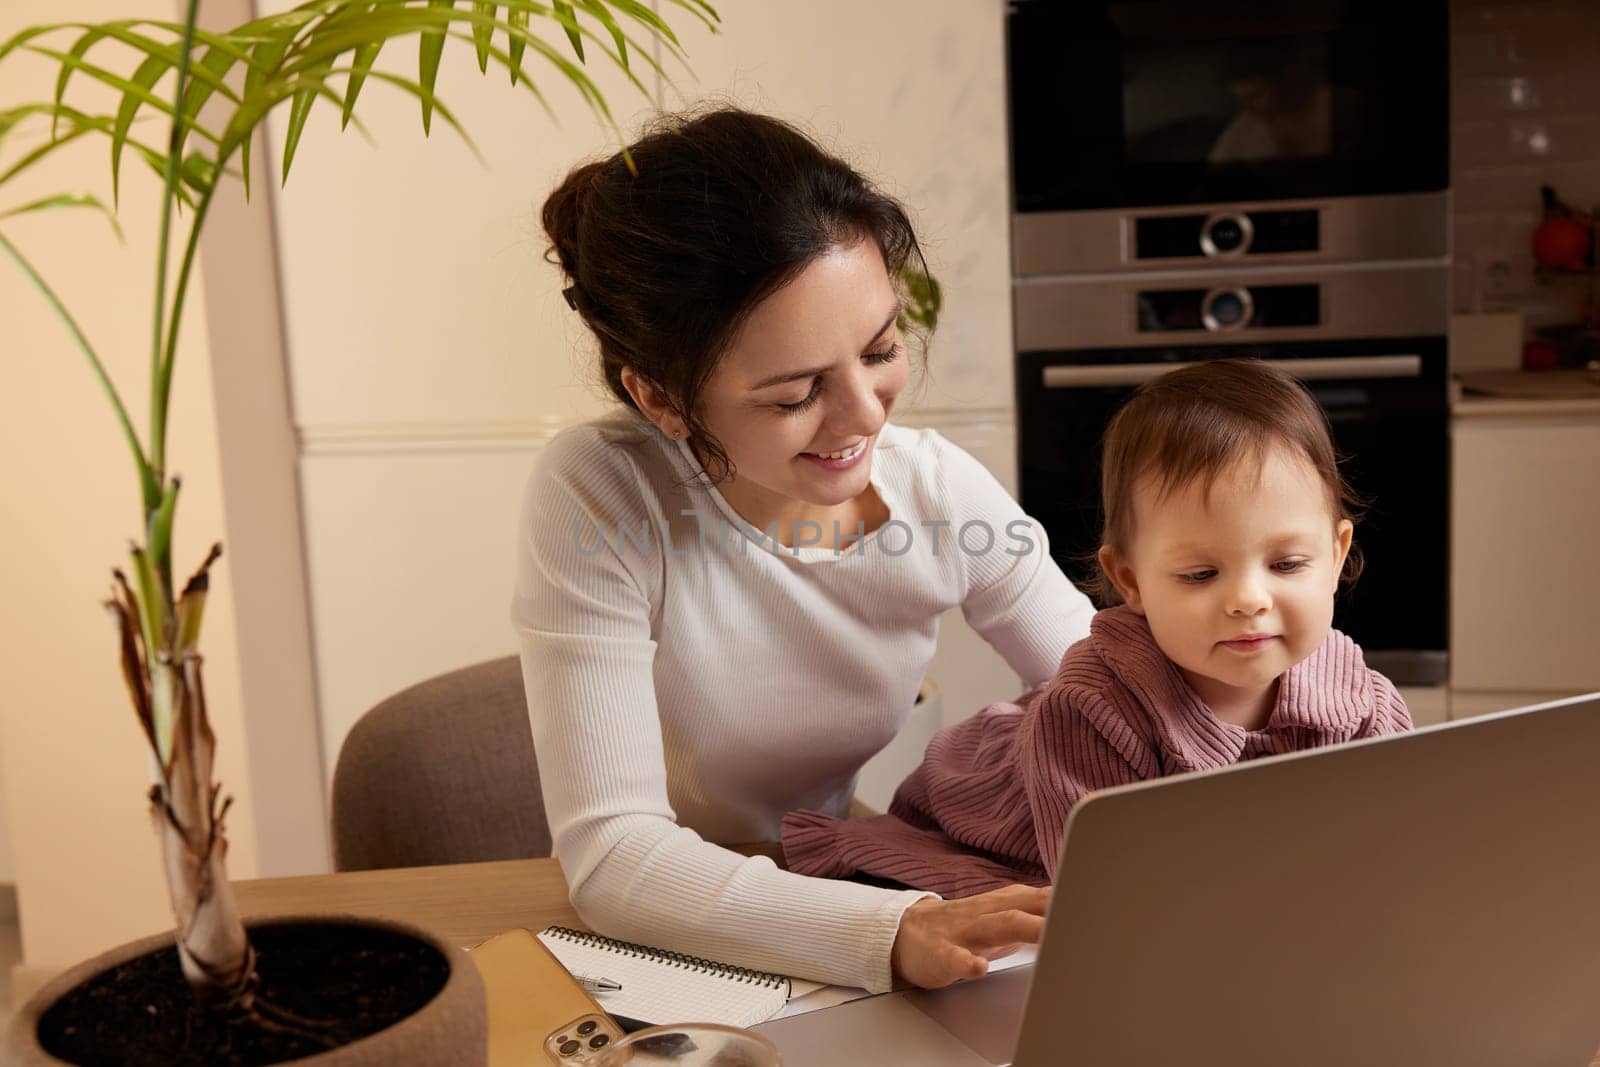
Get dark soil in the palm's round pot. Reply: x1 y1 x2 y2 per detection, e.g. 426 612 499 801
38 923 450 1067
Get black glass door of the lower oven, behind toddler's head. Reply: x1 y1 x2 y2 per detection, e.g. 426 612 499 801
1016 338 1450 685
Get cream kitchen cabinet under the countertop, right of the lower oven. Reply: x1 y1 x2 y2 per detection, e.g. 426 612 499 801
1450 398 1600 694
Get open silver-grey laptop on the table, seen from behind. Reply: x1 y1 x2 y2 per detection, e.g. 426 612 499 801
755 693 1600 1067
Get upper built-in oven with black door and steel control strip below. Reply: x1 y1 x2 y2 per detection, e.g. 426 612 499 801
1006 0 1450 275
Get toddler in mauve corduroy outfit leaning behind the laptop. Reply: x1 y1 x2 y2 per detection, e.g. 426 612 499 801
782 360 1411 897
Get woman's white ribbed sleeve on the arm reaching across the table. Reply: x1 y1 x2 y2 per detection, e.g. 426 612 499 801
514 435 925 990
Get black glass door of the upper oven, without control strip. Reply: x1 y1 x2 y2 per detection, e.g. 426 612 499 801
1006 0 1450 211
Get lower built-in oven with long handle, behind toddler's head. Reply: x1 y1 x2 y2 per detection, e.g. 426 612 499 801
1014 262 1450 685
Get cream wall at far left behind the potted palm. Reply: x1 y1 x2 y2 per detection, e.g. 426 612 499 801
0 0 256 971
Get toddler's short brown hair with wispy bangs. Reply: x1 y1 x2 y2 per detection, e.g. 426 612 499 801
1090 358 1362 606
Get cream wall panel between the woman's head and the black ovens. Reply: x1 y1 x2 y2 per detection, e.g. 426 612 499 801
664 0 1013 418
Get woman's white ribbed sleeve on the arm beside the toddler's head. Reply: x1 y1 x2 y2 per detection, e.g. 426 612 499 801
936 437 1094 686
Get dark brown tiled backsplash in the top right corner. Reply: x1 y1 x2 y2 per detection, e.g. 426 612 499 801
1450 0 1600 326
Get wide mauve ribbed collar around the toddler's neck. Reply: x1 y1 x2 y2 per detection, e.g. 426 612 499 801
1090 606 1374 771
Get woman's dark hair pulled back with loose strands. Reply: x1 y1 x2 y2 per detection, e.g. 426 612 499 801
542 106 926 482
